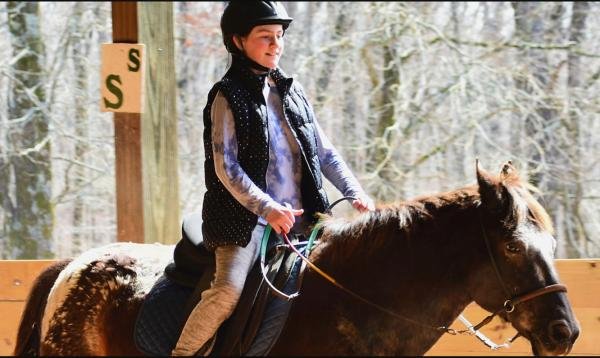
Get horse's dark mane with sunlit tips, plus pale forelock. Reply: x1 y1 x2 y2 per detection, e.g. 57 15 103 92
315 173 553 257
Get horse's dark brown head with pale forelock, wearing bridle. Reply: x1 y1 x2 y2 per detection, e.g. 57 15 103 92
471 162 579 355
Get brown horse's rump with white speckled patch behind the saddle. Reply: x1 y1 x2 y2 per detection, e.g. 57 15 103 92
41 242 174 355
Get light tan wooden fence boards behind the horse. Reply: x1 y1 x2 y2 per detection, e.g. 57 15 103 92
0 259 600 356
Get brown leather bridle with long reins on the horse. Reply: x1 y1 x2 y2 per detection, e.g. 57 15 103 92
261 197 567 349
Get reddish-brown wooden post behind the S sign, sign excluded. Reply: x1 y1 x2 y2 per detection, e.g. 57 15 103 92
111 1 144 243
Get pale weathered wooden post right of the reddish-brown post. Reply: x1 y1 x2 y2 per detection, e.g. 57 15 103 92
138 1 181 244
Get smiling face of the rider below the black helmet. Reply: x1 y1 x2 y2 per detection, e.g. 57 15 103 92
233 24 283 69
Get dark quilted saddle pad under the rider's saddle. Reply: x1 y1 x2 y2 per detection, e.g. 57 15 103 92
134 250 302 356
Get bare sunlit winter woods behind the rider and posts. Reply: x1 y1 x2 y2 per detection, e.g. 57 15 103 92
0 1 600 259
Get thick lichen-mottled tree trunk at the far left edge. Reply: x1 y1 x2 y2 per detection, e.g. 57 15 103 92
1 1 54 258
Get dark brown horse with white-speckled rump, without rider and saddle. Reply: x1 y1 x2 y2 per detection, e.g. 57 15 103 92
15 161 579 356
